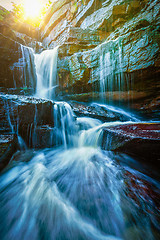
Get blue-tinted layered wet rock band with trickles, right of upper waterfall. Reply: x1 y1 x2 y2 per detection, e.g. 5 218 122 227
58 22 160 96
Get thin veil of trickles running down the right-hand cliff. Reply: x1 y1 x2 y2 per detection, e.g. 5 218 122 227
97 39 131 103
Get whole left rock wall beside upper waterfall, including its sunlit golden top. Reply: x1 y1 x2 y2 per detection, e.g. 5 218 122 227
0 6 40 89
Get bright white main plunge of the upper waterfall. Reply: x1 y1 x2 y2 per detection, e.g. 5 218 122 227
35 47 58 99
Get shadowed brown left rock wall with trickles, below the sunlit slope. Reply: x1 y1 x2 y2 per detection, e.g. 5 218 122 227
0 33 36 91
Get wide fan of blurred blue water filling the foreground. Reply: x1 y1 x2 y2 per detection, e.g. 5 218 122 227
0 124 159 240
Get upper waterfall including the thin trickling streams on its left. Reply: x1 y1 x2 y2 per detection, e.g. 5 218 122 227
11 44 58 99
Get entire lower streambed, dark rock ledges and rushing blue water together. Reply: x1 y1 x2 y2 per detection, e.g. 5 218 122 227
0 94 160 240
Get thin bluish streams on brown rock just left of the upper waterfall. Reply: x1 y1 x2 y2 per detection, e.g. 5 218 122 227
12 44 36 89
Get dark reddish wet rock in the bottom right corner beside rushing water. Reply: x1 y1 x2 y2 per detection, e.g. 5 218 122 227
123 170 160 239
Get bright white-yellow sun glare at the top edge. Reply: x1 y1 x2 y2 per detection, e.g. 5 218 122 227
24 0 42 19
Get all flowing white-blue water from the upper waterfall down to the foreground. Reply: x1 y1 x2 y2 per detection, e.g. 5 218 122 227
0 47 160 240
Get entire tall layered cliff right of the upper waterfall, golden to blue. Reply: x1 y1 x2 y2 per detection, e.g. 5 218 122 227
42 0 160 112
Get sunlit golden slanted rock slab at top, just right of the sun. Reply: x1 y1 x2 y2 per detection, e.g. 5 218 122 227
41 0 101 45
